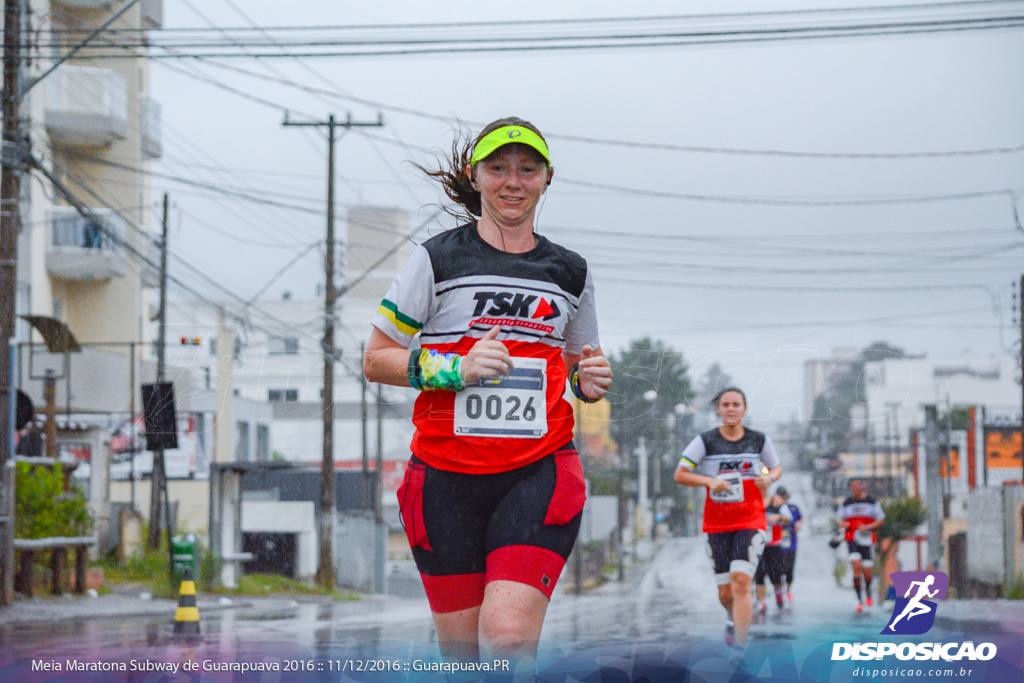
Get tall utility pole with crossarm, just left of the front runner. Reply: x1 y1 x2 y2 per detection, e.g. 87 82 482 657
283 114 384 588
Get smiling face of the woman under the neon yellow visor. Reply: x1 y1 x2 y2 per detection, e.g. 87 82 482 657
473 144 548 227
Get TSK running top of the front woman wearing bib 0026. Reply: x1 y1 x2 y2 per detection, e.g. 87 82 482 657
373 222 599 474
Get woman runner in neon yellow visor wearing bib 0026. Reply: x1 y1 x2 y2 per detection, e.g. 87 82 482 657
364 118 611 659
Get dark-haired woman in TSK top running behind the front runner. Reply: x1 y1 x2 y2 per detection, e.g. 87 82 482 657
675 387 782 657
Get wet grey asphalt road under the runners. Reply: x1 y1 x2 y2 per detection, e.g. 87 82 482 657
0 475 1015 659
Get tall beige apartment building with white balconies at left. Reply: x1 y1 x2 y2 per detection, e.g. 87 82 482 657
17 0 163 405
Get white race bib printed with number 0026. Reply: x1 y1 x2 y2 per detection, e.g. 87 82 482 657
454 357 548 438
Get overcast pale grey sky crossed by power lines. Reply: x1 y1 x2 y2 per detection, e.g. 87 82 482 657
151 0 1024 428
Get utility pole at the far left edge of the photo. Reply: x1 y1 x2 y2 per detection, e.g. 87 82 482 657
0 0 23 607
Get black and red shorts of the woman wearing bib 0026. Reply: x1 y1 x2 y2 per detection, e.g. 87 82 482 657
398 442 586 612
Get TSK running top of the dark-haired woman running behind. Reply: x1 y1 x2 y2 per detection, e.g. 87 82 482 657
679 428 779 533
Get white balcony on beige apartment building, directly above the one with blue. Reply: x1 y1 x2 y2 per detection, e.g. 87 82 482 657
45 65 128 146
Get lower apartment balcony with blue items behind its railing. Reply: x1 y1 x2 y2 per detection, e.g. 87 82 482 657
46 206 128 282
